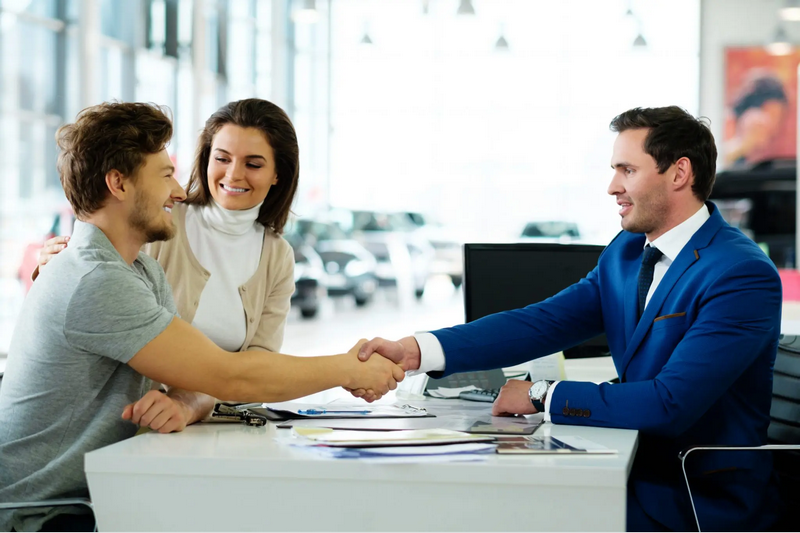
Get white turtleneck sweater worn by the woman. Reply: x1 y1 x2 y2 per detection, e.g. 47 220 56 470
186 200 264 352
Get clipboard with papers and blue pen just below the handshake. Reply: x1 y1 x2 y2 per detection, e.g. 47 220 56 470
249 402 434 421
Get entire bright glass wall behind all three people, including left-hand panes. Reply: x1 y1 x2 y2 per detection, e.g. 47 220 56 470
0 0 700 352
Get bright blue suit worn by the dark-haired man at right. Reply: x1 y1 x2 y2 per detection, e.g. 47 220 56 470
433 203 781 530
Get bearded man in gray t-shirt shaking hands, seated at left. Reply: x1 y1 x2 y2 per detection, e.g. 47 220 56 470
0 103 404 531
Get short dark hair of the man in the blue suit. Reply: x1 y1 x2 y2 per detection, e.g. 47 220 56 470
609 106 717 201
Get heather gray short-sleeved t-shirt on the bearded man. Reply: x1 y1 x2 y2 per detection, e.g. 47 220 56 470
0 222 177 531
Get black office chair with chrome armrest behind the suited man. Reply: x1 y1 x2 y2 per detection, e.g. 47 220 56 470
678 335 800 531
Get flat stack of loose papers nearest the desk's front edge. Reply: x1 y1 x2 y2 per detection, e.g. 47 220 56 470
292 427 494 448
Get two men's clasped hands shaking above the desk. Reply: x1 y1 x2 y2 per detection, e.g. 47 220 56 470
344 337 420 403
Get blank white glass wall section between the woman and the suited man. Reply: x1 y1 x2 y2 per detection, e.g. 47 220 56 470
324 0 699 243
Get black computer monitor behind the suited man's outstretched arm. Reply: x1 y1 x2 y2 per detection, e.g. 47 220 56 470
464 243 609 359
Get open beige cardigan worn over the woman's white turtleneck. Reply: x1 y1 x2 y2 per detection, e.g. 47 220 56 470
142 203 294 352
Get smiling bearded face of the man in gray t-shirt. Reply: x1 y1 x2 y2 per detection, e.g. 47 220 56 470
128 150 186 242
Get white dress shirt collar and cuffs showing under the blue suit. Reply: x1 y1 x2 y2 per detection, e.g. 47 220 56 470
416 204 711 422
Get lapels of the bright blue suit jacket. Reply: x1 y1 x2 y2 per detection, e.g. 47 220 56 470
618 202 725 378
